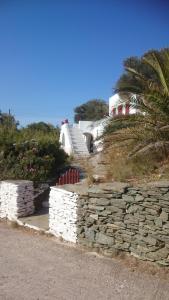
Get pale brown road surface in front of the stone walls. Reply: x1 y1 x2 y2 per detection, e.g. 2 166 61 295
0 223 169 300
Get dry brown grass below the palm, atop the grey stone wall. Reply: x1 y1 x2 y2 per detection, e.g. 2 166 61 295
105 145 169 183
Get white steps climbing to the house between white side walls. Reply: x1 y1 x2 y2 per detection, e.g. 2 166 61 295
69 127 89 157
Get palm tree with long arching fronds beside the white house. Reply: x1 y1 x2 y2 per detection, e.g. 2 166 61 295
105 48 169 156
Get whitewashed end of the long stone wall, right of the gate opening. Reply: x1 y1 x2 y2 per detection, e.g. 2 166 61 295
49 187 78 243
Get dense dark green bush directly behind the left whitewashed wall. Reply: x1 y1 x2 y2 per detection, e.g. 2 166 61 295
0 140 67 181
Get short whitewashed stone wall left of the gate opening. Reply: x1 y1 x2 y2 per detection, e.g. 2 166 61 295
0 180 34 220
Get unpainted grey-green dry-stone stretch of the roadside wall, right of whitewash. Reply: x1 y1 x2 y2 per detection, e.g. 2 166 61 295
54 181 169 265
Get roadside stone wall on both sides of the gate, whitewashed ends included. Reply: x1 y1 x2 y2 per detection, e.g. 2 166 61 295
0 180 169 265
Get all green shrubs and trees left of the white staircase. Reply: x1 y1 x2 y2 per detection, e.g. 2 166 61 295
0 113 67 181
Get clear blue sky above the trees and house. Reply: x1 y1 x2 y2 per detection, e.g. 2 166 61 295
0 0 169 126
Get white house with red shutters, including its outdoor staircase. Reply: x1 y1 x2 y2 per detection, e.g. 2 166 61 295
60 94 136 157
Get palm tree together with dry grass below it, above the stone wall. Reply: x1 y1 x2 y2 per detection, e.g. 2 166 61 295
104 48 169 180
